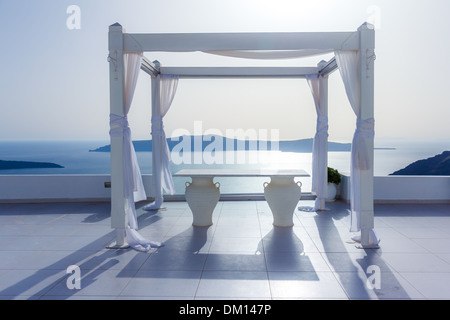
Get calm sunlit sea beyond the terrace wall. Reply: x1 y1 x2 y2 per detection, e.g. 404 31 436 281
0 141 450 193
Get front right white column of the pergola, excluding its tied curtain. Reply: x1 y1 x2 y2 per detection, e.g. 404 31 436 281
358 23 375 248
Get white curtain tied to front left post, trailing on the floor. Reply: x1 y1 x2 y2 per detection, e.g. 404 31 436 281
110 53 162 251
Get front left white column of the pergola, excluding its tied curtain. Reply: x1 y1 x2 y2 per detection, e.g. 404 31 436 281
108 23 127 247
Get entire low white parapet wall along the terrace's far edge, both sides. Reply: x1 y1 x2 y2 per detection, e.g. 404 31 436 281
0 174 450 203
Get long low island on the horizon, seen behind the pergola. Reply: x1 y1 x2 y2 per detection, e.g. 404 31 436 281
90 136 351 152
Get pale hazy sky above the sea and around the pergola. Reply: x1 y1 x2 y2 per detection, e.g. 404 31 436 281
0 0 450 142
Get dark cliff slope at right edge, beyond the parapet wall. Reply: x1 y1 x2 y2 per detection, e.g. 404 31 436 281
391 151 450 176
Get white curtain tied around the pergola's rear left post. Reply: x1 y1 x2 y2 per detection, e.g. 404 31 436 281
144 74 179 210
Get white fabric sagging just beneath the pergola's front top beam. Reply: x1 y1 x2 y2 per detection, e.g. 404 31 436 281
202 49 333 60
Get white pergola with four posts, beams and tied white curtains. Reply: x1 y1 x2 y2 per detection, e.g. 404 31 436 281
108 23 378 250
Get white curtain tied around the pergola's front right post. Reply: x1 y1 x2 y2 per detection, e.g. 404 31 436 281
335 50 379 244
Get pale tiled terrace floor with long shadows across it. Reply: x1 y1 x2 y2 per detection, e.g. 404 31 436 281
0 201 450 300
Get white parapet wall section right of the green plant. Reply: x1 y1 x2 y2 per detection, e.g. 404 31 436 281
339 174 450 203
